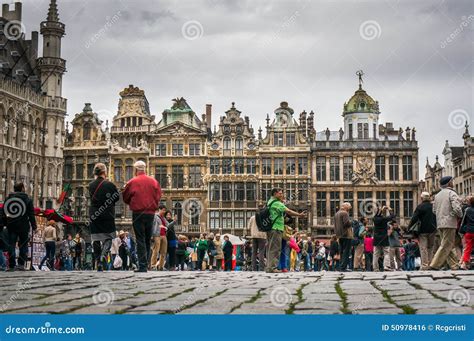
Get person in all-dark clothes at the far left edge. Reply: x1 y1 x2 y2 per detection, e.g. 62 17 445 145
3 182 36 271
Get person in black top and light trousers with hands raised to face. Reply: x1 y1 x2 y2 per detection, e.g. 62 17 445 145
373 206 395 271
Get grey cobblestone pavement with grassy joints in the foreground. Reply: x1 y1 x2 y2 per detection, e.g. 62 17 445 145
0 271 474 314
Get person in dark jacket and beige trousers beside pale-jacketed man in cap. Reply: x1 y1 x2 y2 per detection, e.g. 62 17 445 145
408 192 436 270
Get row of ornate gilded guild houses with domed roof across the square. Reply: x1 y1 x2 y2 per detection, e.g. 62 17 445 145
64 72 419 238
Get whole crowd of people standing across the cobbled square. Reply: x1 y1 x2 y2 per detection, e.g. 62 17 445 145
0 161 474 273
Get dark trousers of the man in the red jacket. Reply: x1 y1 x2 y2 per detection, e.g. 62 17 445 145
132 212 154 271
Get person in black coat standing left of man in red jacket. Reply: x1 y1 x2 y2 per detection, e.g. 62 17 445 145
89 163 120 271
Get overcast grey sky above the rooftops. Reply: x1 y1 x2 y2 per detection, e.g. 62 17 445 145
17 0 474 177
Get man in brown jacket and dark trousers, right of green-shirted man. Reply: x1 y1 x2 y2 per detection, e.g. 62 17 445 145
334 202 353 272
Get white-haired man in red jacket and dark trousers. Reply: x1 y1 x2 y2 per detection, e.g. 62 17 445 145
123 161 161 272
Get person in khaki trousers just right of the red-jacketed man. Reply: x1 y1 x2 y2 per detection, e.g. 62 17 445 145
149 205 168 271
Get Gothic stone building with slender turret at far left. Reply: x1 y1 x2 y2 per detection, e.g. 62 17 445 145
0 0 66 208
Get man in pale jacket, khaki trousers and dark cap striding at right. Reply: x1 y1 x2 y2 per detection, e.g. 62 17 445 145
430 176 463 270
